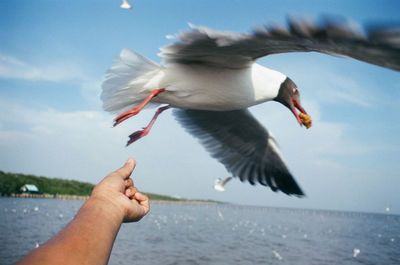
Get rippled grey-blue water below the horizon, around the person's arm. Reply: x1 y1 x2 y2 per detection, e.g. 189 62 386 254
0 198 400 265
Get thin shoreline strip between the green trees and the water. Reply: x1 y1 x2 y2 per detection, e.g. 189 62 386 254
3 193 218 205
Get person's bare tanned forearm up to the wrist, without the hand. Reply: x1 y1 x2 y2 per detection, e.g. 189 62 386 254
17 198 123 265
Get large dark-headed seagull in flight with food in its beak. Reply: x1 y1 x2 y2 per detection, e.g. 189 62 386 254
101 15 400 196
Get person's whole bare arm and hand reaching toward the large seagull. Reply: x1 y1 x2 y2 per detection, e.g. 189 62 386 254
16 158 150 265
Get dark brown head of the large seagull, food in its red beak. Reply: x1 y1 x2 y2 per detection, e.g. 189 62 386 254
274 77 311 129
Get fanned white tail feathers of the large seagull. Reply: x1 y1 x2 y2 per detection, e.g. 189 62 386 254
101 48 162 113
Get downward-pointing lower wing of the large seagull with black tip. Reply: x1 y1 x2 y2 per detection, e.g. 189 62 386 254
174 109 304 196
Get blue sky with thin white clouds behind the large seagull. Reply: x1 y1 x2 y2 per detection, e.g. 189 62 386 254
0 0 400 214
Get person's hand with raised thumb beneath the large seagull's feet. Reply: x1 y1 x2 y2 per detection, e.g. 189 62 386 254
89 158 150 222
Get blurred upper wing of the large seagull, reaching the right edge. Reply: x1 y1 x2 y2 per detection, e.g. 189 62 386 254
160 18 400 70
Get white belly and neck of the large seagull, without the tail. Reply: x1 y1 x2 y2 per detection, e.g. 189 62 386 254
156 63 286 111
